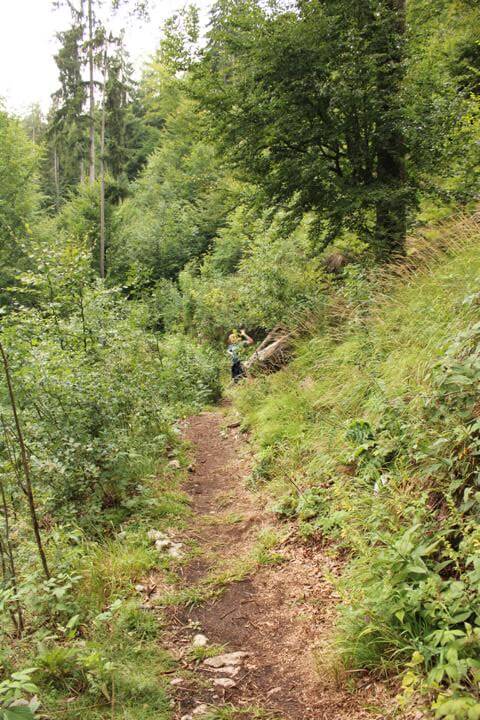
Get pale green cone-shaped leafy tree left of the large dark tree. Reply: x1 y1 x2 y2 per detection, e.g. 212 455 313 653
112 94 232 281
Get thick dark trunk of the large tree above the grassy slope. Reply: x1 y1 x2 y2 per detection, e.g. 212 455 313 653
374 0 407 261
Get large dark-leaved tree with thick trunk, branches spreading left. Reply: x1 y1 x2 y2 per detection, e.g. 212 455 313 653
197 0 411 256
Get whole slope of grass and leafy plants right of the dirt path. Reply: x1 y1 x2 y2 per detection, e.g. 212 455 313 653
236 219 480 720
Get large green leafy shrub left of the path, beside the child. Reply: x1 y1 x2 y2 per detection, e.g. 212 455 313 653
0 270 221 533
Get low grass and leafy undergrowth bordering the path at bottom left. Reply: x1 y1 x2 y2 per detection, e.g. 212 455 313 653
0 461 190 720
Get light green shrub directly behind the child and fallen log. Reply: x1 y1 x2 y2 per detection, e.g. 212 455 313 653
179 209 329 343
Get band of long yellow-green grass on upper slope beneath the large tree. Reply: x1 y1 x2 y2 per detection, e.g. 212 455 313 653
237 219 480 490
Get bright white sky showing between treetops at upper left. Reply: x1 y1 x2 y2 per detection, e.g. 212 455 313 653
0 0 211 114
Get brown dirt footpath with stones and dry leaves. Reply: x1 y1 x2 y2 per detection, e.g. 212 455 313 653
167 408 386 720
